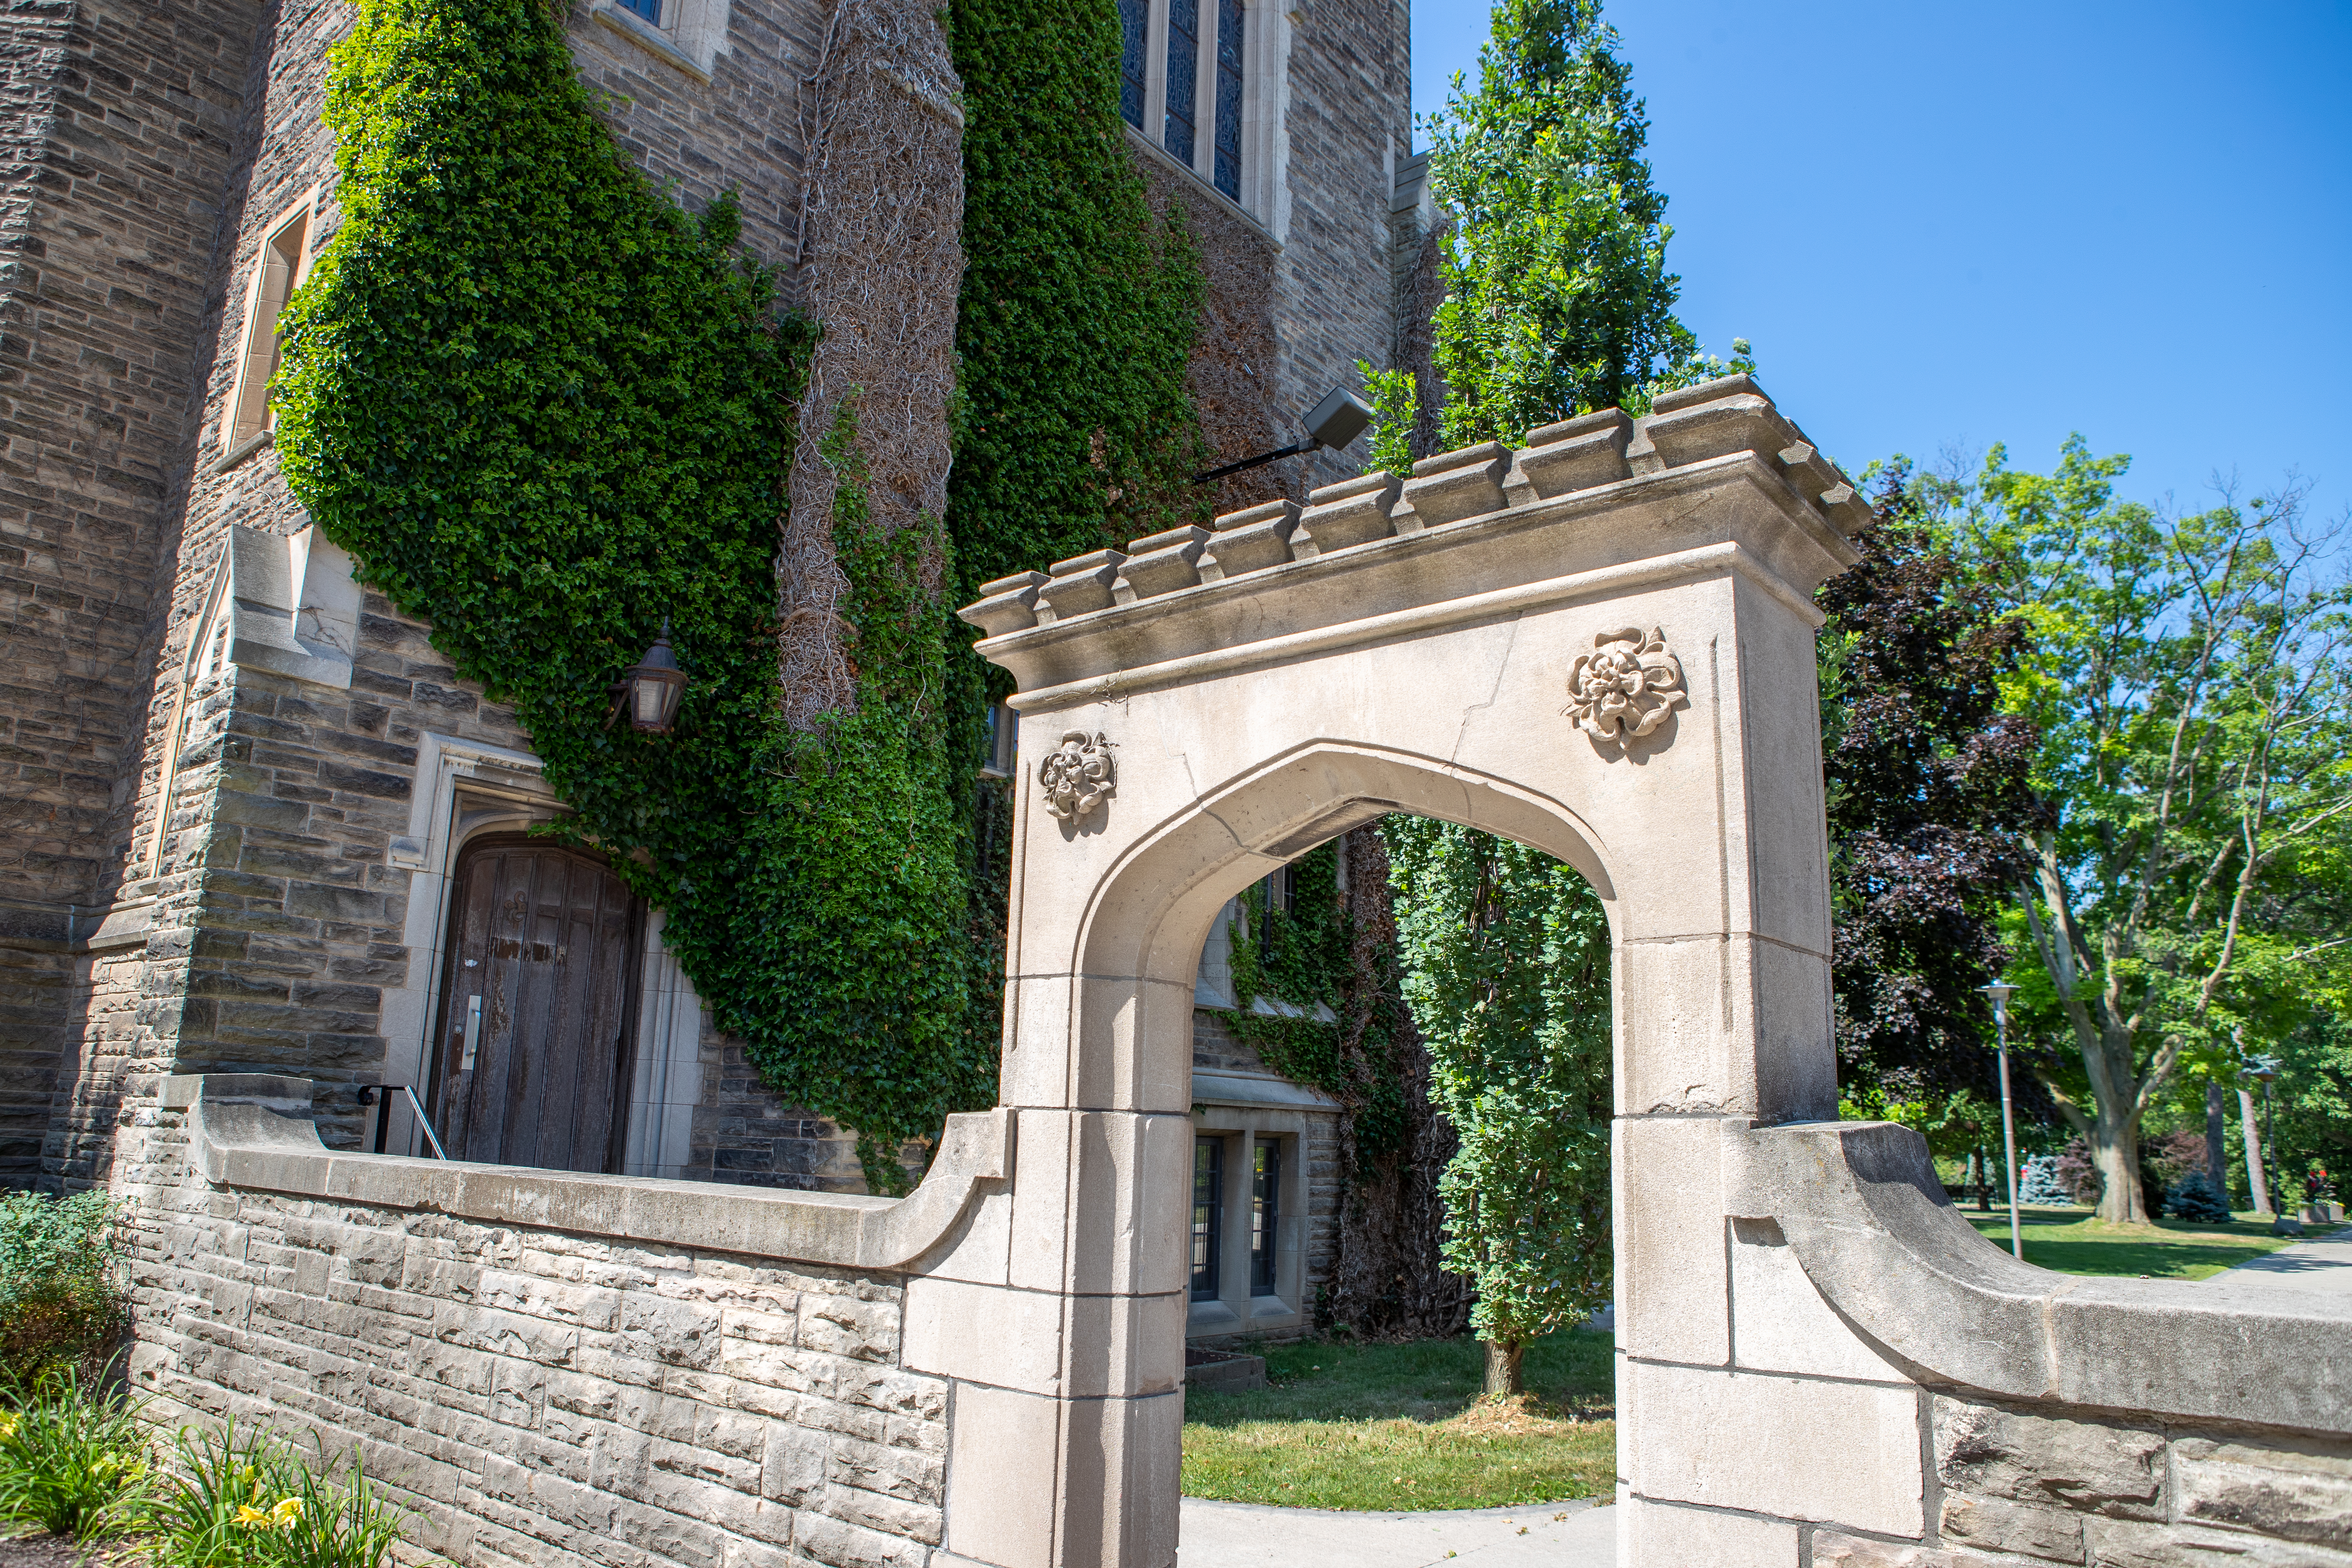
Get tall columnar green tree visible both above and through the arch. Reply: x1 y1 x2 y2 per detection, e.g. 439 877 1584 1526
1374 0 1750 1394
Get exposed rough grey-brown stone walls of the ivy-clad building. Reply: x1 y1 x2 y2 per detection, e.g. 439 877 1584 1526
0 0 1421 1333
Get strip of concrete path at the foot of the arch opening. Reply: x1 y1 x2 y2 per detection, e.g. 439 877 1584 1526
1176 1498 1616 1568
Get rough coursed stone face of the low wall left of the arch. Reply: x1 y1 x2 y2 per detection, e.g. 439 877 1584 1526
122 1109 948 1568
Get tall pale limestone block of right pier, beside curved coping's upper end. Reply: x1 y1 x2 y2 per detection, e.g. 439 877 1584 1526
1611 1117 1731 1366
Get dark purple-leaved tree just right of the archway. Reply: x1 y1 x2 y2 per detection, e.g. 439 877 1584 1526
1820 459 2042 1109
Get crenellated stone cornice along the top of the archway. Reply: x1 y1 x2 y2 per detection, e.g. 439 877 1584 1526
960 376 1870 712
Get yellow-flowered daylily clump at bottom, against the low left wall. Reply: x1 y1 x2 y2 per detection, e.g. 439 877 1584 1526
146 1422 402 1568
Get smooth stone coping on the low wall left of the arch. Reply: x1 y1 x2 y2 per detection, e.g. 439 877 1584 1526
158 1072 1014 1269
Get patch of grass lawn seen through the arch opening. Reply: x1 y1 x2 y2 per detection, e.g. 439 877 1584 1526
1183 1333 1616 1509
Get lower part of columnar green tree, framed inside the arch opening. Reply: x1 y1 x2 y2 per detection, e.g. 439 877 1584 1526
1381 816 1611 1394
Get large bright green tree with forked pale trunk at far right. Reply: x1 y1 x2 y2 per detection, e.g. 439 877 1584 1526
1933 437 2352 1222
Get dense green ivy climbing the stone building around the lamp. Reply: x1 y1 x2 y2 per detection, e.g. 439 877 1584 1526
278 0 1202 1187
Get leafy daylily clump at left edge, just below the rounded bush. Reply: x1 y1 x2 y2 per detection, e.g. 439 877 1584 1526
0 1361 150 1540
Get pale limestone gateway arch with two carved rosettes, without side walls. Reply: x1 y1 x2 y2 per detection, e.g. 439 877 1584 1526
908 379 1853 1568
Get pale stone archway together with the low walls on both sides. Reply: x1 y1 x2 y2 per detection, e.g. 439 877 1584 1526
134 376 2352 1568
